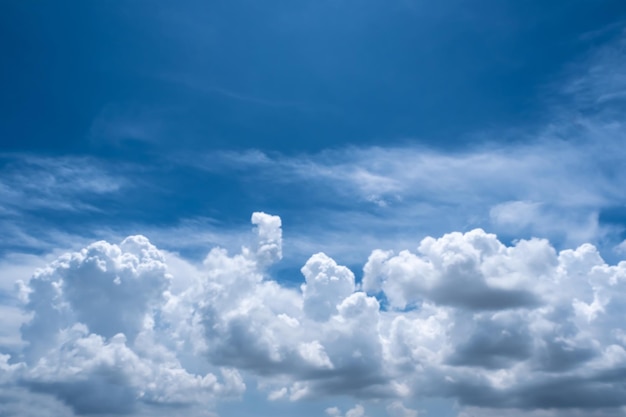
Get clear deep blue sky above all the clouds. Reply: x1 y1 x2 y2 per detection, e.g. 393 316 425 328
0 0 626 154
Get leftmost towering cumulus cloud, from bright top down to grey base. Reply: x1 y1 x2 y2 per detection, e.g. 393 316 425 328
6 232 244 415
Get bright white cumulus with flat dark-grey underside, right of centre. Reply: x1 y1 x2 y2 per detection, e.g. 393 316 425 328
363 229 544 309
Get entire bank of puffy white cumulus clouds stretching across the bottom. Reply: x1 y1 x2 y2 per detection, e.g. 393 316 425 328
0 213 626 416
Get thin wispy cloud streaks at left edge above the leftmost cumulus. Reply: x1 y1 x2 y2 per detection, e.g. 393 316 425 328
0 153 132 255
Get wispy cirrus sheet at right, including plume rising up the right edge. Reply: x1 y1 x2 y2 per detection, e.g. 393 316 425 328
185 32 626 255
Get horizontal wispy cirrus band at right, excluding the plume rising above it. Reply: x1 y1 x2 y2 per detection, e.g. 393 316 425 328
194 115 626 252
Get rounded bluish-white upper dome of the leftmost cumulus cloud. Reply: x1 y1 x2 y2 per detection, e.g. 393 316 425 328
23 236 170 358
